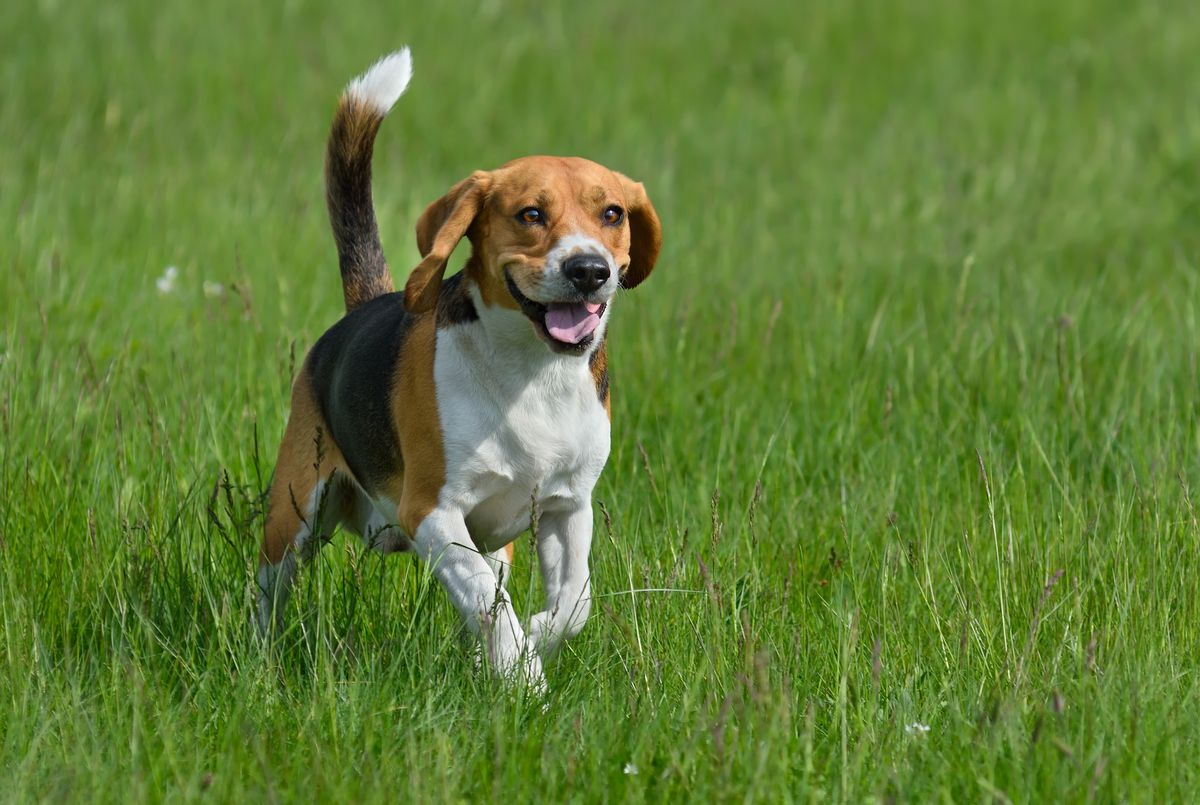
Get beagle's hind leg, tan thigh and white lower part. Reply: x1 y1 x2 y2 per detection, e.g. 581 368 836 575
257 370 349 637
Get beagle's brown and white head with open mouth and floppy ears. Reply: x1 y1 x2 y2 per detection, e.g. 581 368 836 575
404 157 662 353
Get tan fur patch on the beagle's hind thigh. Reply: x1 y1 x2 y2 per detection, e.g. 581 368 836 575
259 367 348 565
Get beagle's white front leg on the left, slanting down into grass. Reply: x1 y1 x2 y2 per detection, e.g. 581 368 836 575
413 507 546 689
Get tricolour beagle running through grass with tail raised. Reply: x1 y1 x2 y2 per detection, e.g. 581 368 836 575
258 48 662 687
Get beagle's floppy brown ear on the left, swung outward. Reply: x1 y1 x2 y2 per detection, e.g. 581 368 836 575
404 170 492 313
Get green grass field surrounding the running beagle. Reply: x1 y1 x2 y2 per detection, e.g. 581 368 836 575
0 0 1200 801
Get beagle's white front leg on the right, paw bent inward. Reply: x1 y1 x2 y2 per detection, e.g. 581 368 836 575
529 500 592 657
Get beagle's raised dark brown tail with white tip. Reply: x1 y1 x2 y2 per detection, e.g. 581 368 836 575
325 48 413 313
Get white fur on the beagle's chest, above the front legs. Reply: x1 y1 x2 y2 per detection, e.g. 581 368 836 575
434 323 610 551
